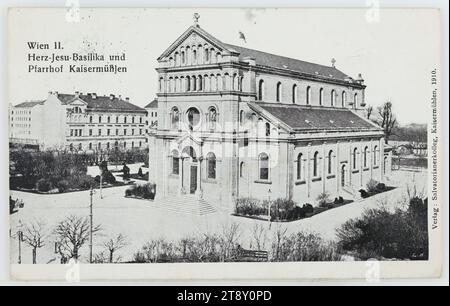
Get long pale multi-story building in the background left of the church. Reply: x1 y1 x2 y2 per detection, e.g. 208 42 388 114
10 92 147 152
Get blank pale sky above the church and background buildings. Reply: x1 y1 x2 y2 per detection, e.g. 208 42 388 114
8 8 441 124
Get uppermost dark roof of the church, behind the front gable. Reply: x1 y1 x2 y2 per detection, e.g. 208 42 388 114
225 44 348 81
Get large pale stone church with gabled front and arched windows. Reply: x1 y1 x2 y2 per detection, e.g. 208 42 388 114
149 24 390 211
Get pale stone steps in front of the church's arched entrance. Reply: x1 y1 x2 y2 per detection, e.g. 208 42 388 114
151 195 217 216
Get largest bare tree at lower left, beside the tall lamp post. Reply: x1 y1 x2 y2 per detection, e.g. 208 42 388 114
54 215 101 261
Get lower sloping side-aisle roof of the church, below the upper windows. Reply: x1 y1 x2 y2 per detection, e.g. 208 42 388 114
251 103 379 131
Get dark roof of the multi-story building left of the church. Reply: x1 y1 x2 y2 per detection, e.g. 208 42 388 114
58 94 146 113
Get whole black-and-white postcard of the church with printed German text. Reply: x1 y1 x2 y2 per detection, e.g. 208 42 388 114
4 1 448 282
